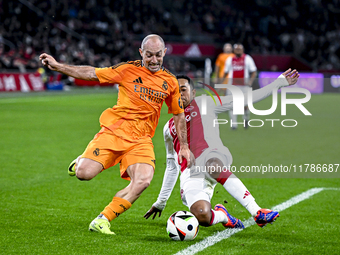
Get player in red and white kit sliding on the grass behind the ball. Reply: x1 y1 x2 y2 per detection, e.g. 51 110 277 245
144 69 299 228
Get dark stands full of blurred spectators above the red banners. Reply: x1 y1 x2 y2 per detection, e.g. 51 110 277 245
0 0 340 71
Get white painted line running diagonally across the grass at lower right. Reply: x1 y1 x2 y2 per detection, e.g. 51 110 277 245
175 188 340 255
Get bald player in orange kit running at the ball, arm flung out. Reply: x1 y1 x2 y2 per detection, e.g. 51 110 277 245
40 35 194 234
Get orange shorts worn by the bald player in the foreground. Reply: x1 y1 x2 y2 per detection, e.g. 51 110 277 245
81 127 155 180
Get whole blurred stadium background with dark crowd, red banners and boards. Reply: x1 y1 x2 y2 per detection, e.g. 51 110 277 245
0 0 340 92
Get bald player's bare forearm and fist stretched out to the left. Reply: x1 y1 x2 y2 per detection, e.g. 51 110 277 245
39 53 99 81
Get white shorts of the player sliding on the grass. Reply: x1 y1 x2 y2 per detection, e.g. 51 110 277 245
180 146 233 210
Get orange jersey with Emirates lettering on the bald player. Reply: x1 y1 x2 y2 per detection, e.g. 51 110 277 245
95 60 184 142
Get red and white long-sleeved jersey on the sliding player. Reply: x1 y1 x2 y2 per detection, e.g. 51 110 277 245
163 75 289 171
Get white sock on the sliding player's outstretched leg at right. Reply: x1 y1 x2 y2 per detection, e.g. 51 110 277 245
223 174 261 217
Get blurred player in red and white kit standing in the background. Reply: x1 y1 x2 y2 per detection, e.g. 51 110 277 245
224 43 257 129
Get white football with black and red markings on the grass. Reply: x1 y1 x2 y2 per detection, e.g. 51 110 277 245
166 211 199 241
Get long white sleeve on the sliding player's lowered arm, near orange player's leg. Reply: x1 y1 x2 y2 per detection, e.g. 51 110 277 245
153 122 180 210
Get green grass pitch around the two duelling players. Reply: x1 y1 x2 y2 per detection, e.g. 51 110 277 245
0 89 340 254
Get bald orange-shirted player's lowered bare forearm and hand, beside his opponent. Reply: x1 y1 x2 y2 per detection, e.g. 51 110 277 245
174 113 195 167
